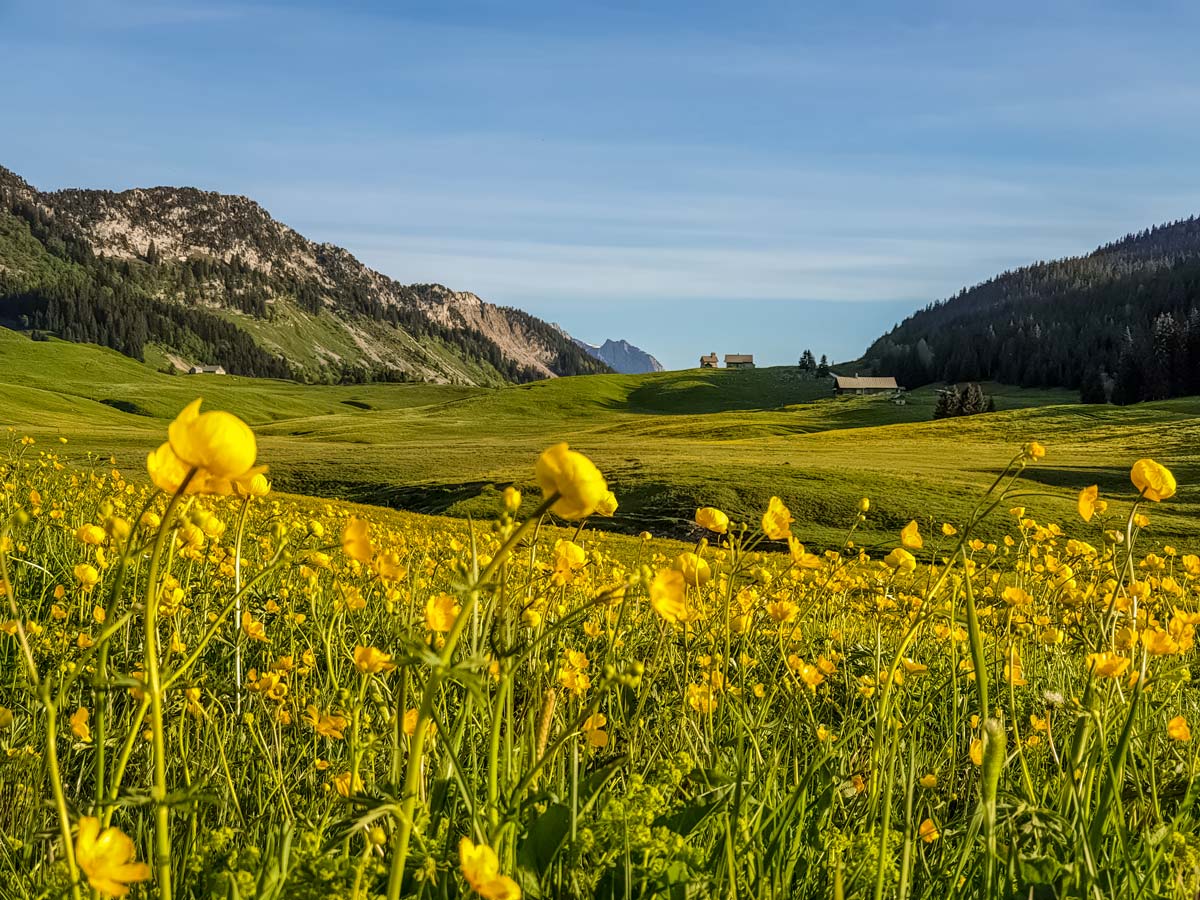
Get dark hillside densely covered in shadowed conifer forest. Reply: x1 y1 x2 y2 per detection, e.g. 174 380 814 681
864 216 1200 403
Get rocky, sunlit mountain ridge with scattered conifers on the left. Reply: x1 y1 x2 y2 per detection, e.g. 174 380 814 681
0 167 610 384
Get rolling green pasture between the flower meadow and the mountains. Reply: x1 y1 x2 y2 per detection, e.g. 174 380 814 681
0 331 1200 544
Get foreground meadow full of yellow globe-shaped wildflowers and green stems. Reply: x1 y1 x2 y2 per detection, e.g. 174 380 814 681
0 401 1200 900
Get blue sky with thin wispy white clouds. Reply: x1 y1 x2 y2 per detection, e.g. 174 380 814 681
0 0 1200 367
